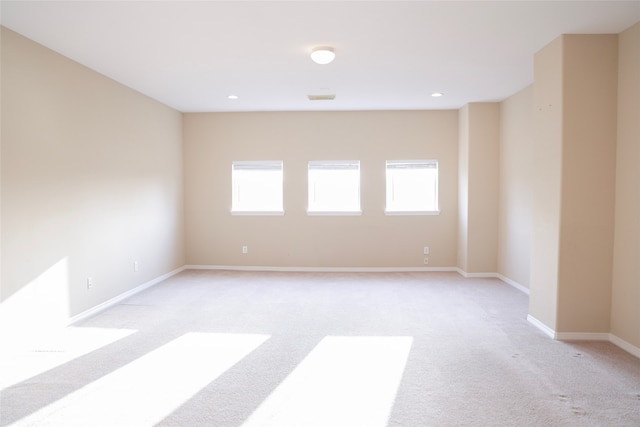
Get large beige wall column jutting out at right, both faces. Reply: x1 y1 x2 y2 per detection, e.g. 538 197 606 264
530 35 617 333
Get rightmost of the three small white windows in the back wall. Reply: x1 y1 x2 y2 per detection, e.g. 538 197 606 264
386 160 440 215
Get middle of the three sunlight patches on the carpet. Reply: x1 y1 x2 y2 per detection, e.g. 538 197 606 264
14 332 269 427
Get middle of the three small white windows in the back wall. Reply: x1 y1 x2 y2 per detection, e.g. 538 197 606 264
308 160 361 215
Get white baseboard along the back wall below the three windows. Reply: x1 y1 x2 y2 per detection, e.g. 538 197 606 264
184 265 457 273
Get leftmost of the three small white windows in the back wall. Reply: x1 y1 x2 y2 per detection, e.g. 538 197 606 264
231 161 284 215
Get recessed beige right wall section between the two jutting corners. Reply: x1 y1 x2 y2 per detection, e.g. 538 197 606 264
498 86 536 288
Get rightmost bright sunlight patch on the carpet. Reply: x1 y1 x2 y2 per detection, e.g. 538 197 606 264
243 336 413 427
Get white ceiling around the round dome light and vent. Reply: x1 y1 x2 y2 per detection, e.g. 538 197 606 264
0 0 640 112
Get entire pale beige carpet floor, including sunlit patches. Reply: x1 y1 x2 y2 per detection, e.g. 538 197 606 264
0 271 640 427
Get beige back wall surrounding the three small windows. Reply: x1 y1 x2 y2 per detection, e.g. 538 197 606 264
184 111 458 267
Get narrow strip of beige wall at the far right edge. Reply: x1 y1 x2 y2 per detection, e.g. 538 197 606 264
611 23 640 348
